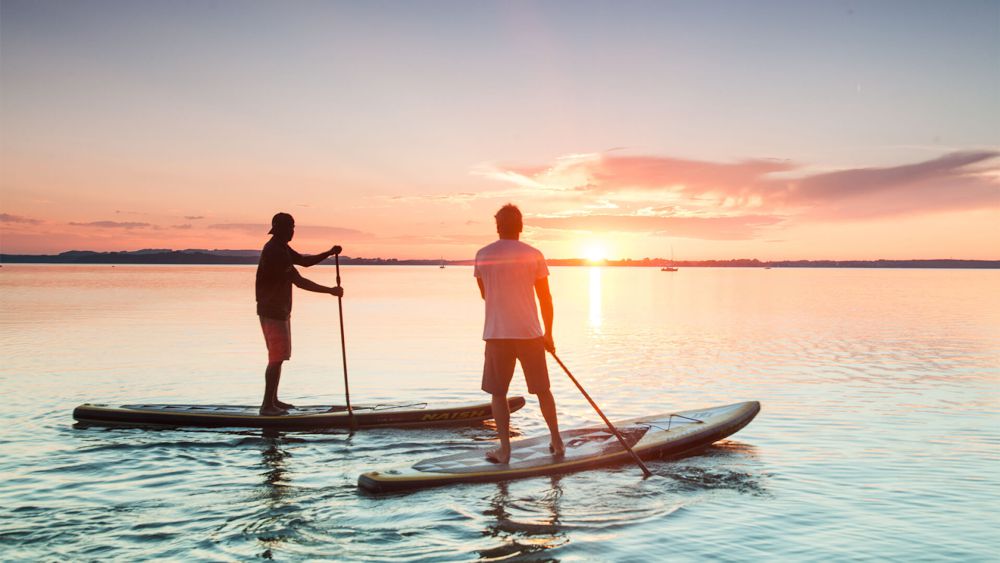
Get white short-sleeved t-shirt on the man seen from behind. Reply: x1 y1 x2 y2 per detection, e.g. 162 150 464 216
473 239 549 340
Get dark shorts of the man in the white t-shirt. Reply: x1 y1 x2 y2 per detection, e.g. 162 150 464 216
483 338 549 395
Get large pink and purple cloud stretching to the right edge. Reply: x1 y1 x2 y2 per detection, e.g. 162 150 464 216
488 150 1000 224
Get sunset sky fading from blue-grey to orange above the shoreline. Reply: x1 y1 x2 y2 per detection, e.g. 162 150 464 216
0 0 1000 260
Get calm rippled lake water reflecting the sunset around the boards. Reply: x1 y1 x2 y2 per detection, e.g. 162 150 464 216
0 264 1000 561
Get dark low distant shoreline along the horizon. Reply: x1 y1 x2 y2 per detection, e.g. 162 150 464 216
0 249 1000 269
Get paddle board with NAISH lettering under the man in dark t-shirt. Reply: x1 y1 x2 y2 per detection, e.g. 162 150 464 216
73 397 524 429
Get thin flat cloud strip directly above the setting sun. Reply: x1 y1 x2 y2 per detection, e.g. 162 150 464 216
525 215 783 240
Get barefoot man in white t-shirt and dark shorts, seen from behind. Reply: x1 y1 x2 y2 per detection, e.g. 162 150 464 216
474 203 565 464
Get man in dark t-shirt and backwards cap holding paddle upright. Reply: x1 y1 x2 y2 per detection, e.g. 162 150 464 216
256 213 344 416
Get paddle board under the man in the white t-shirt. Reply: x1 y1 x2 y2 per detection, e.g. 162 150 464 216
358 401 760 492
